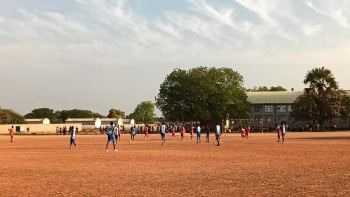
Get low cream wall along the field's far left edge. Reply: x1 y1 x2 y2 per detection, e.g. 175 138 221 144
0 124 82 134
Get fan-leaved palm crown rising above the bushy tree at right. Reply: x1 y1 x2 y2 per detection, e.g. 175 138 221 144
304 67 339 94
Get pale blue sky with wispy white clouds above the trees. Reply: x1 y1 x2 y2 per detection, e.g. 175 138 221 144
0 0 350 115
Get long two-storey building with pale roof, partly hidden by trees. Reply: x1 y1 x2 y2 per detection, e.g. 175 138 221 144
247 91 350 128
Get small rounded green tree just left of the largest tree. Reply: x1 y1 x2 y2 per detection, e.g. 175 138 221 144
129 101 155 124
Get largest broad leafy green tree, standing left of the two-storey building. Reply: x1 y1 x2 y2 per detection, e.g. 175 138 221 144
156 67 250 121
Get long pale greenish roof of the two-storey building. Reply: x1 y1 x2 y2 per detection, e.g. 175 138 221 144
247 91 304 104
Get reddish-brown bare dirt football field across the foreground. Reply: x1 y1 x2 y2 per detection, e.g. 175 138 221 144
0 132 350 196
